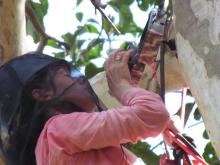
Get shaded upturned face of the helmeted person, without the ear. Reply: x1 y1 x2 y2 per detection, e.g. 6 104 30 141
53 67 97 112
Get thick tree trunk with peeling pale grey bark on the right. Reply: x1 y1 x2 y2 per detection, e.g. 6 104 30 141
173 0 220 157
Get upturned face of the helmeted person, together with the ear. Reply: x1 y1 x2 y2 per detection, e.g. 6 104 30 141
32 66 97 112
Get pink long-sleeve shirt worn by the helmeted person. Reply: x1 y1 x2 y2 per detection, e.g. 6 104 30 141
35 88 169 165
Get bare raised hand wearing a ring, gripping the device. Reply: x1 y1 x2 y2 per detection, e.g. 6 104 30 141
105 49 133 99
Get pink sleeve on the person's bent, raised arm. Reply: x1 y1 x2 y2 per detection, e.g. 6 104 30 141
38 88 169 154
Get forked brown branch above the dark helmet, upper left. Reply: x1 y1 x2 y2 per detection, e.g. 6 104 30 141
25 1 70 52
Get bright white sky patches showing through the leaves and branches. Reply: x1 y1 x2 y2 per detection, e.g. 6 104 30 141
27 0 207 160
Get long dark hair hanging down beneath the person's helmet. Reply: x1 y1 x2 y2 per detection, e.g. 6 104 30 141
14 62 54 165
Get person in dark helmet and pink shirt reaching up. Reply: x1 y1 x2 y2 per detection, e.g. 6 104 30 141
0 49 173 165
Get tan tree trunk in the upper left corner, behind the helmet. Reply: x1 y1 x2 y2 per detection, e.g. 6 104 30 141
0 0 26 65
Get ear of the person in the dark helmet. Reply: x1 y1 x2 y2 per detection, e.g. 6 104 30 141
32 89 53 101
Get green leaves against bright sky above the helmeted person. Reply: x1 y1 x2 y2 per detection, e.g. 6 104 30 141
27 0 151 77
